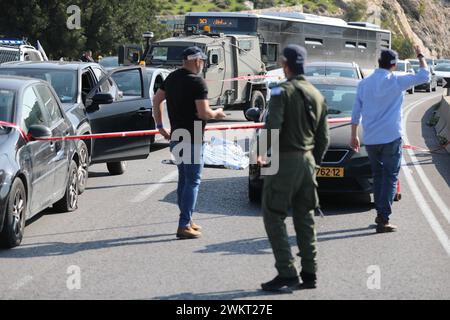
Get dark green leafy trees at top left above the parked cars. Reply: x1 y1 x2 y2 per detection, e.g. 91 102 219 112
0 0 167 59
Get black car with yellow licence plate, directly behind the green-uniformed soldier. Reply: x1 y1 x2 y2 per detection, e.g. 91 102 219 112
248 77 400 202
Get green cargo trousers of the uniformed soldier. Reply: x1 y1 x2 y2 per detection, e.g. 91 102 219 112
262 152 319 277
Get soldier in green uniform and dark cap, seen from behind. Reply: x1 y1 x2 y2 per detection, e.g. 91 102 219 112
258 45 329 291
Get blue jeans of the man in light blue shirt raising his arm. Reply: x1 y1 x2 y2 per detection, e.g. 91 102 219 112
366 138 402 220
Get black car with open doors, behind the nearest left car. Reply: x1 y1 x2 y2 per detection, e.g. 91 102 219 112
0 61 155 192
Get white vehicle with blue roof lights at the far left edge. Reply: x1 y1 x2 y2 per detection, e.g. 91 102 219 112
0 39 45 63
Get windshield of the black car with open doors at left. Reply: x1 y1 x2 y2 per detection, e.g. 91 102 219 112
0 68 77 103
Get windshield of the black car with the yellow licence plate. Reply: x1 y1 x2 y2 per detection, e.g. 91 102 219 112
314 84 356 118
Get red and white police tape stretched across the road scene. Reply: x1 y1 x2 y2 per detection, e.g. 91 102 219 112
0 117 450 153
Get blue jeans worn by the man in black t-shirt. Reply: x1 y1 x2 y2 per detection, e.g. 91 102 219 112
170 142 204 228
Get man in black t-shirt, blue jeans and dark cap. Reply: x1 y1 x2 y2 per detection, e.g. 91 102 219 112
153 47 225 239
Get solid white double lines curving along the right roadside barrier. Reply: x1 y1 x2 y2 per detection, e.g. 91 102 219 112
402 96 450 256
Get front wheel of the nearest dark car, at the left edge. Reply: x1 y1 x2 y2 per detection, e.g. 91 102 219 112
0 179 27 249
